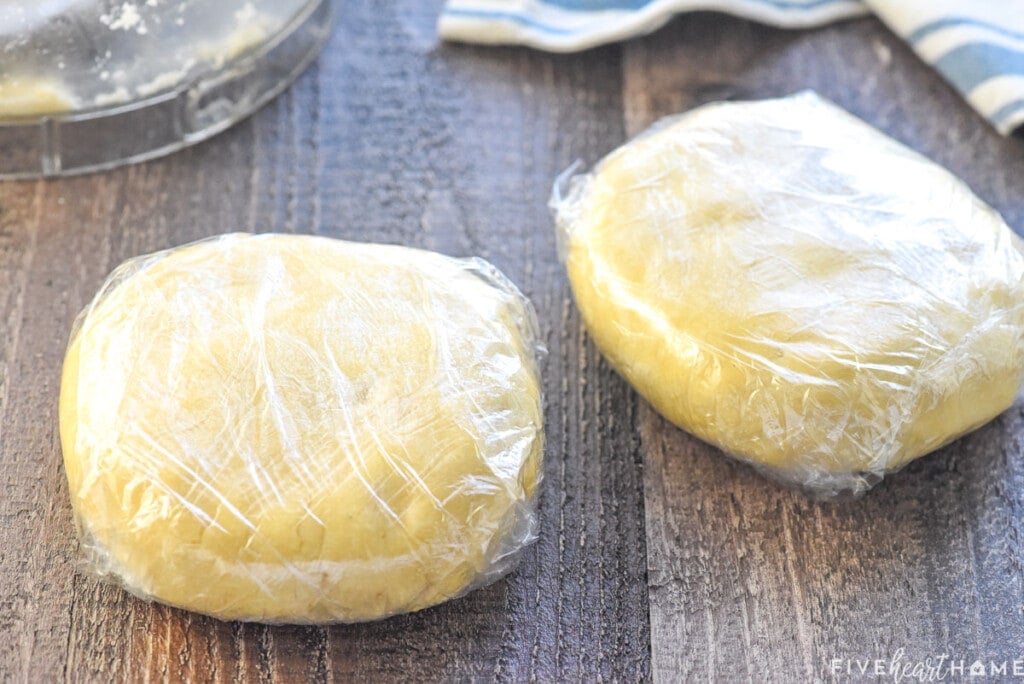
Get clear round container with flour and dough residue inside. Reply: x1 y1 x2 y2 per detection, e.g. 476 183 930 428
0 0 332 178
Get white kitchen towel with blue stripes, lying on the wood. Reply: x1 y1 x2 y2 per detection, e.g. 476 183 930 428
438 0 1024 135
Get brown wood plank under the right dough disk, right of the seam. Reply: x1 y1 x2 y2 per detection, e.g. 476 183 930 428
624 14 1024 681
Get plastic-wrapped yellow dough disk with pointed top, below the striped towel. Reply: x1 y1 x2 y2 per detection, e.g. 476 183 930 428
552 93 1024 494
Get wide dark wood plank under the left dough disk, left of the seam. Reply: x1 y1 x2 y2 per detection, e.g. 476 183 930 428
0 0 649 682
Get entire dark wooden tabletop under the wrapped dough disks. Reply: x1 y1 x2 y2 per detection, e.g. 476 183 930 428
0 0 1024 682
